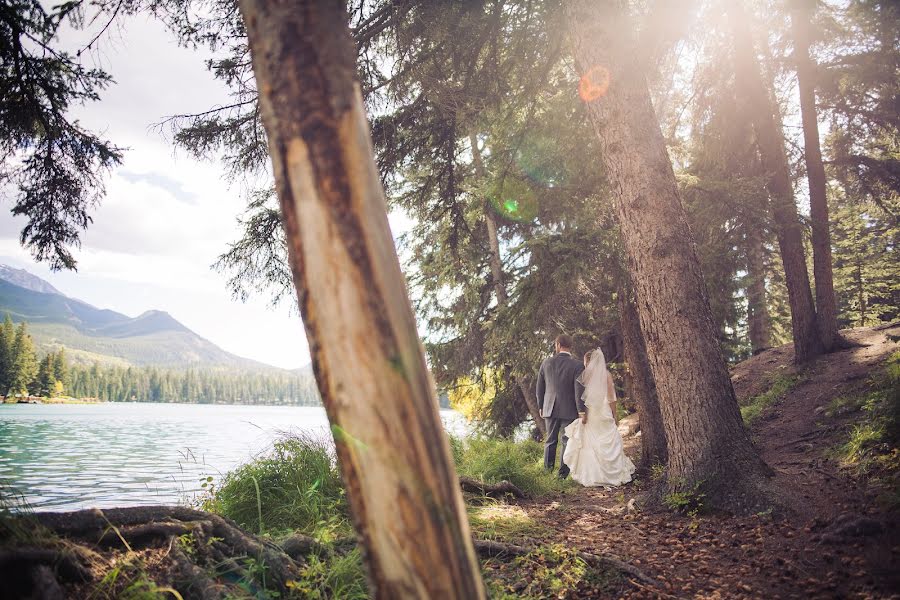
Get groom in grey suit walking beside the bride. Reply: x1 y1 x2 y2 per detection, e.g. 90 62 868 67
537 334 585 479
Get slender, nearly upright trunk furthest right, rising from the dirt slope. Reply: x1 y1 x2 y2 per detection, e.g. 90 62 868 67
791 0 840 352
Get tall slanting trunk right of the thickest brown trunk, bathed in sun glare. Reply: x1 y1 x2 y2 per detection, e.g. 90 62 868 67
726 0 822 362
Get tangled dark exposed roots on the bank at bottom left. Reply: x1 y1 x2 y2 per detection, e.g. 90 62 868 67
8 506 302 600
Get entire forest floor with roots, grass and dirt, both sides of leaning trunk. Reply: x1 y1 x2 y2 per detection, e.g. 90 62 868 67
0 325 900 600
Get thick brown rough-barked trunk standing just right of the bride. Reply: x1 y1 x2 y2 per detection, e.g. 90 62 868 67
567 0 766 510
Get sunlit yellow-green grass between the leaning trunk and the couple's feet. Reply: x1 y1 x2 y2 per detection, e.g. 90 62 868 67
454 437 571 496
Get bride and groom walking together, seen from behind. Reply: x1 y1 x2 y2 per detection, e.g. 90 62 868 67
537 334 634 486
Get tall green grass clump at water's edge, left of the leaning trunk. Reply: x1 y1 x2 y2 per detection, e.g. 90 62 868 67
202 436 349 540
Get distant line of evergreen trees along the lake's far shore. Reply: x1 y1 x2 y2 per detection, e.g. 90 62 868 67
0 314 321 406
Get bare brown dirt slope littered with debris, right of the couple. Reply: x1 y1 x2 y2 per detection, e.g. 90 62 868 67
492 326 900 598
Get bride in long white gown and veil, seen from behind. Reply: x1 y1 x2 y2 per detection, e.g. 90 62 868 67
563 348 634 486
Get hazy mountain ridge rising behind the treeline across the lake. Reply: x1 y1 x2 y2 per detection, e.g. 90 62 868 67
0 265 280 371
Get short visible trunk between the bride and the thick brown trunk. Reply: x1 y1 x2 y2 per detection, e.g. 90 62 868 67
618 285 669 467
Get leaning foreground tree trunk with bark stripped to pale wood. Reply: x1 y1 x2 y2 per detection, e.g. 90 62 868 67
240 0 485 598
